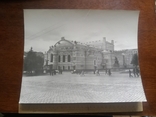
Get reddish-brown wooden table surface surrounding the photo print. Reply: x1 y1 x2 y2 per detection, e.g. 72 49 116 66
0 0 156 115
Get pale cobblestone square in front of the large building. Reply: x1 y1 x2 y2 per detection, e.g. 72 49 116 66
19 72 146 103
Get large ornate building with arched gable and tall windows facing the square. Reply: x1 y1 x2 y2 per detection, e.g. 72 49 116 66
44 37 114 70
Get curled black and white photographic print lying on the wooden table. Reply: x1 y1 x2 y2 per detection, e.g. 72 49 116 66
19 9 146 112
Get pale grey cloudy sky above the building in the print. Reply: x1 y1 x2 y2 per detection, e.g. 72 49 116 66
24 9 139 52
